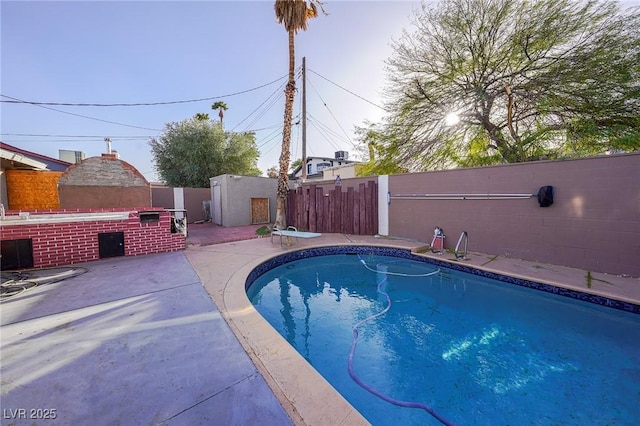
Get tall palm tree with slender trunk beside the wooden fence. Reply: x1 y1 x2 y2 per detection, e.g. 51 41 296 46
275 0 322 229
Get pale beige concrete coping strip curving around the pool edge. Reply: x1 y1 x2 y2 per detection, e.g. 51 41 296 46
188 234 640 425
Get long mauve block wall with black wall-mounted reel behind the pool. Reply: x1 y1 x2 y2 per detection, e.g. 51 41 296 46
389 153 640 276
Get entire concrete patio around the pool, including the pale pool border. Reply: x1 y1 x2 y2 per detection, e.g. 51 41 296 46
0 230 640 425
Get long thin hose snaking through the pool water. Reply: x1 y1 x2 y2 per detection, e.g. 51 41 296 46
347 254 453 426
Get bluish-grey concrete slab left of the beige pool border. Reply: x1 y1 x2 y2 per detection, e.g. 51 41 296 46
0 252 291 425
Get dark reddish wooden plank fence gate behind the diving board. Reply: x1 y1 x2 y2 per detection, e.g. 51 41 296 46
287 181 378 235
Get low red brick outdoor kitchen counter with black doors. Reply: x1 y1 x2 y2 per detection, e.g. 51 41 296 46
2 209 186 268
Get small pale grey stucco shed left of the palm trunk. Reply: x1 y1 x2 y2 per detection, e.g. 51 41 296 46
211 175 278 226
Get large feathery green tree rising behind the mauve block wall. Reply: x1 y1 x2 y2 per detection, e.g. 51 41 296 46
383 0 640 170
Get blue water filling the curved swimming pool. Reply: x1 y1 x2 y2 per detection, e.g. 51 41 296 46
247 249 640 425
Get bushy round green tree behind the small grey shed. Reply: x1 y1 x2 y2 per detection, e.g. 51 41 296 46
149 116 262 188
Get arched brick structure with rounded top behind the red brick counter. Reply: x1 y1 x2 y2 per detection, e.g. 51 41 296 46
58 154 151 209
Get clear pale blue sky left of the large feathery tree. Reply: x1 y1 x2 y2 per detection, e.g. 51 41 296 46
0 0 419 181
